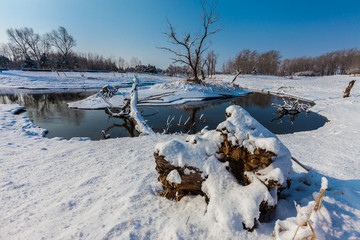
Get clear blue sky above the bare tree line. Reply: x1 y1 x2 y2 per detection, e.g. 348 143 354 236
0 0 360 69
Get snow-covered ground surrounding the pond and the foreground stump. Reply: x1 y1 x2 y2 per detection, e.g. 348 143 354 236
0 71 360 239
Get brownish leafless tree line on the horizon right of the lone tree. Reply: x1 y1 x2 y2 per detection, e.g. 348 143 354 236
222 48 360 76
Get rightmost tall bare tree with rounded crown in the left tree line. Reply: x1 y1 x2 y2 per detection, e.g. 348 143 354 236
48 26 76 59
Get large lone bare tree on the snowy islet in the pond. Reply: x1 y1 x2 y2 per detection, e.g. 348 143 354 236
160 1 222 83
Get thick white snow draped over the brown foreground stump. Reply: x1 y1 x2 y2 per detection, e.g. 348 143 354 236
155 106 291 232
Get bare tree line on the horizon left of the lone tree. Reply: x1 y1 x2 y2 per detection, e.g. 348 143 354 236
0 26 162 73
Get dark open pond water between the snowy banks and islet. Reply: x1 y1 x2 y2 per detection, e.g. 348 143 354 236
0 92 327 140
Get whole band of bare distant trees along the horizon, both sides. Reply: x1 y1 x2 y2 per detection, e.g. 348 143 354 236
0 27 360 76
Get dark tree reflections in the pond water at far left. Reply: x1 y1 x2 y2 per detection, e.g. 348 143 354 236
0 93 87 125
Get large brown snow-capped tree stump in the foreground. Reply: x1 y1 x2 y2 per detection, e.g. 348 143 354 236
154 106 291 230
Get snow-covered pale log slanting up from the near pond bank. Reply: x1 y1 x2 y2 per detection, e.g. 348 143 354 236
129 76 154 135
